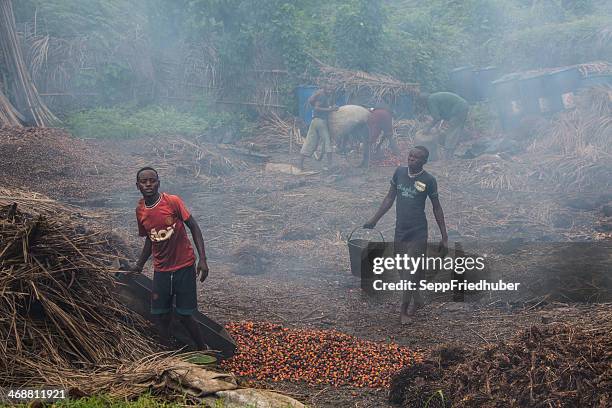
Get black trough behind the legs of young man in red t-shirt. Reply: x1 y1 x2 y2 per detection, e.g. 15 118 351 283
115 273 236 358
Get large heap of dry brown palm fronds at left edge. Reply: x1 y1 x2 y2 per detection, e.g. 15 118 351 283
0 192 154 387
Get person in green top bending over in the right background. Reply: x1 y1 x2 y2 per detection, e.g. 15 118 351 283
419 92 469 158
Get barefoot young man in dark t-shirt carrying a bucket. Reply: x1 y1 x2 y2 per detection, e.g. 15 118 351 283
363 146 448 324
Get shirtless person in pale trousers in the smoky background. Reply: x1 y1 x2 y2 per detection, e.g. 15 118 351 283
298 86 338 170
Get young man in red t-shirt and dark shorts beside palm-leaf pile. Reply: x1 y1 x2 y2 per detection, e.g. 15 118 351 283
132 167 208 348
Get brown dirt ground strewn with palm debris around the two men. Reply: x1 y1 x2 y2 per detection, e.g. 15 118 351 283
5 133 612 407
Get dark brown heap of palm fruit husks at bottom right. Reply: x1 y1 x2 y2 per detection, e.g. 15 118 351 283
389 318 612 408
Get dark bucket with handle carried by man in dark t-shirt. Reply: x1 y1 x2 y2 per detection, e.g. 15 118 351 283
347 227 385 293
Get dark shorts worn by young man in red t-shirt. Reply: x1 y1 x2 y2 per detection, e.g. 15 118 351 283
151 264 198 316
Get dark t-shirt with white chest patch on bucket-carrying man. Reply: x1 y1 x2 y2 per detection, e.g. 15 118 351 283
391 167 438 241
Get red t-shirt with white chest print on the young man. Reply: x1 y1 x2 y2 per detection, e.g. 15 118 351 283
136 193 196 272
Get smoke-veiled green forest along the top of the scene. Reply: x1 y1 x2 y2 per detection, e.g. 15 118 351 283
0 0 612 136
